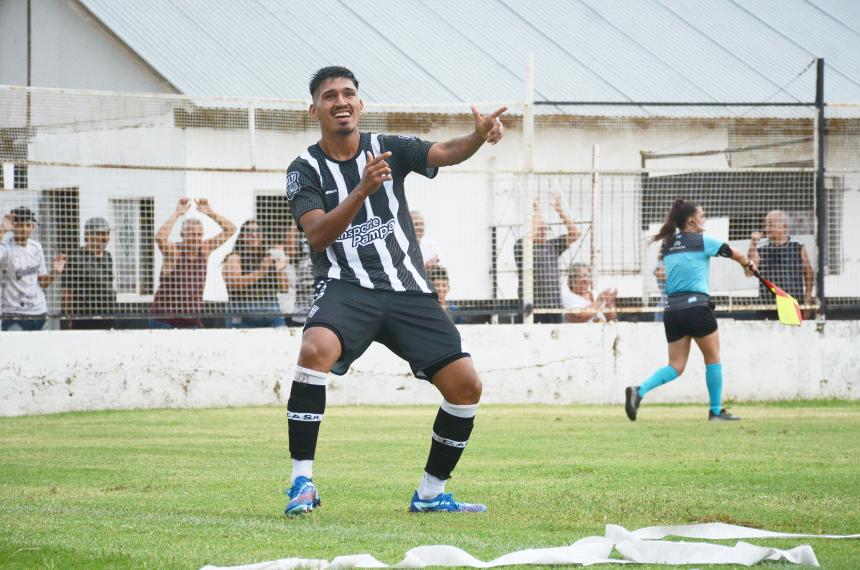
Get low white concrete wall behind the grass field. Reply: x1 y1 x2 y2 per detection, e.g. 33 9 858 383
0 320 860 416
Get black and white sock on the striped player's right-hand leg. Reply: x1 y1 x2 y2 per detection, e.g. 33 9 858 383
419 400 478 488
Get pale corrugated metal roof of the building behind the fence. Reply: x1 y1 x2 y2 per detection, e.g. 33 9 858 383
80 0 860 103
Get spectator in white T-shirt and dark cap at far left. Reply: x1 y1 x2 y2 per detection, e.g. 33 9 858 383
0 206 66 331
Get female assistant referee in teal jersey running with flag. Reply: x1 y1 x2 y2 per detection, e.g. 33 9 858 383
625 200 756 421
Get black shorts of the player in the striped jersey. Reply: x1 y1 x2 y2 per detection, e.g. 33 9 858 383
298 279 469 380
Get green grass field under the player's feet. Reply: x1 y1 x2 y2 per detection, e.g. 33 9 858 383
0 402 860 568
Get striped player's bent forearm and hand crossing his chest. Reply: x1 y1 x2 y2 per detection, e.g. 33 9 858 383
299 152 391 251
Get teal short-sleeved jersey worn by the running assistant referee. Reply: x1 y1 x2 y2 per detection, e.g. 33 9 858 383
662 232 732 295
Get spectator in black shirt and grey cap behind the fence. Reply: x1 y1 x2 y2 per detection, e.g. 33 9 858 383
61 218 116 330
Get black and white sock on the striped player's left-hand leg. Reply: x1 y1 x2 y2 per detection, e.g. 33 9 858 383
287 366 328 480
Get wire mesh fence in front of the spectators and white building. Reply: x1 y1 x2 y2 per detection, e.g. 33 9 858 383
0 82 860 328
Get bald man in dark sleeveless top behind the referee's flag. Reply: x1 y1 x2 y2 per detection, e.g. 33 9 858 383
747 210 815 305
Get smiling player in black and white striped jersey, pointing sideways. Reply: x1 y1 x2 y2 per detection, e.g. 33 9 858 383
284 67 507 515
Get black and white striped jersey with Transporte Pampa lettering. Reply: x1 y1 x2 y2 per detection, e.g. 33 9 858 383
287 133 438 293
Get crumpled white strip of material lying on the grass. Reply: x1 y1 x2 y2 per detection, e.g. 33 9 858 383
202 523 860 570
